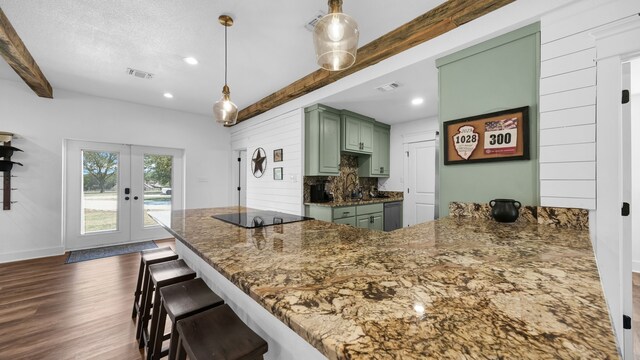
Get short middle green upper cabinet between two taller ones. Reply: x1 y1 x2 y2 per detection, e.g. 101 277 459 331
340 110 374 154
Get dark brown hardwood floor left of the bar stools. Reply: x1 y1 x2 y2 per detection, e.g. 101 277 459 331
0 239 175 360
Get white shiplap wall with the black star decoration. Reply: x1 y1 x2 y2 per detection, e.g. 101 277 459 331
231 109 304 215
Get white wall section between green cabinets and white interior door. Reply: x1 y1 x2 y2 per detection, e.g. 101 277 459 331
378 117 438 191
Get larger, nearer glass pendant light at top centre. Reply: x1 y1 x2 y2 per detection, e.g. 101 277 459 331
313 0 360 71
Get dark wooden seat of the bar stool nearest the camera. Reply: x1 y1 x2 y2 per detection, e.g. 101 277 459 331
177 304 269 360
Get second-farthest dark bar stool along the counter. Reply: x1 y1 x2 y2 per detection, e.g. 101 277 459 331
136 260 196 351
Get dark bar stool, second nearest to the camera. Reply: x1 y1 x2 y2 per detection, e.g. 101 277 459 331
147 279 224 360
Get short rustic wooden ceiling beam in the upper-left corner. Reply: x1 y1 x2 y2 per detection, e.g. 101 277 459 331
0 8 53 99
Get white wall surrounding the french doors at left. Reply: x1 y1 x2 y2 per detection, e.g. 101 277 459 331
0 80 231 262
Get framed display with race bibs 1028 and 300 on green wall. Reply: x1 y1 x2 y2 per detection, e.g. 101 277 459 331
442 106 530 165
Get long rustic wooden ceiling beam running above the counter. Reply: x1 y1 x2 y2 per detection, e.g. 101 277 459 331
238 0 514 123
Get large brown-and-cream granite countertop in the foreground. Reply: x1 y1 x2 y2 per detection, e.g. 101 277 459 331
160 208 619 359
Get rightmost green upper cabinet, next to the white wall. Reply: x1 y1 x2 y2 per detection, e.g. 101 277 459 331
358 122 390 177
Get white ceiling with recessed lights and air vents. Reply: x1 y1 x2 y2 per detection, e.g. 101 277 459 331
0 0 444 122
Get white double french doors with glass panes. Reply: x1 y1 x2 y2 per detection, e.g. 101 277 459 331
65 140 184 250
